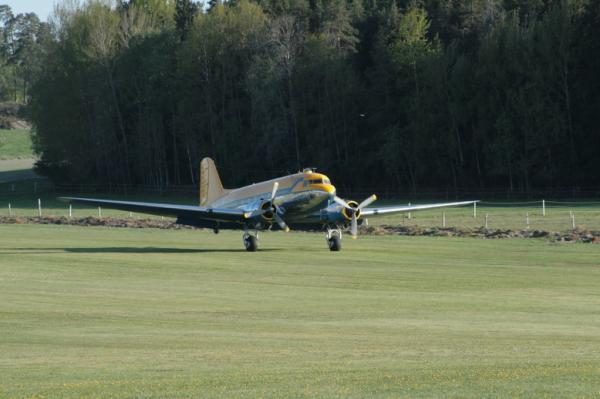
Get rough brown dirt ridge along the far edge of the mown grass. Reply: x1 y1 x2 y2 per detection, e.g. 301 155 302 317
0 216 600 244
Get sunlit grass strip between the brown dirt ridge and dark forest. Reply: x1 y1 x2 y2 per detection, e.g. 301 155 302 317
0 192 600 231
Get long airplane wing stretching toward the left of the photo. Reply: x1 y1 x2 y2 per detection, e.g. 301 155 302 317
59 197 250 223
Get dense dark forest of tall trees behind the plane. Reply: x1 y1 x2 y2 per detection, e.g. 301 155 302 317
0 0 600 193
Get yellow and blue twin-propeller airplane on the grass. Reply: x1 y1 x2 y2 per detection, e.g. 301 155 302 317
60 158 477 251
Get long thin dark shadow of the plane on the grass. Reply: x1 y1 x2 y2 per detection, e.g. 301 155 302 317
0 247 281 254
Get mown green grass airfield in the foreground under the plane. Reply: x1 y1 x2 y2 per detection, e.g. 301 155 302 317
0 225 600 398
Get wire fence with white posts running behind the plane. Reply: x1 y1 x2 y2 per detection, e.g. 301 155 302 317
0 194 600 231
